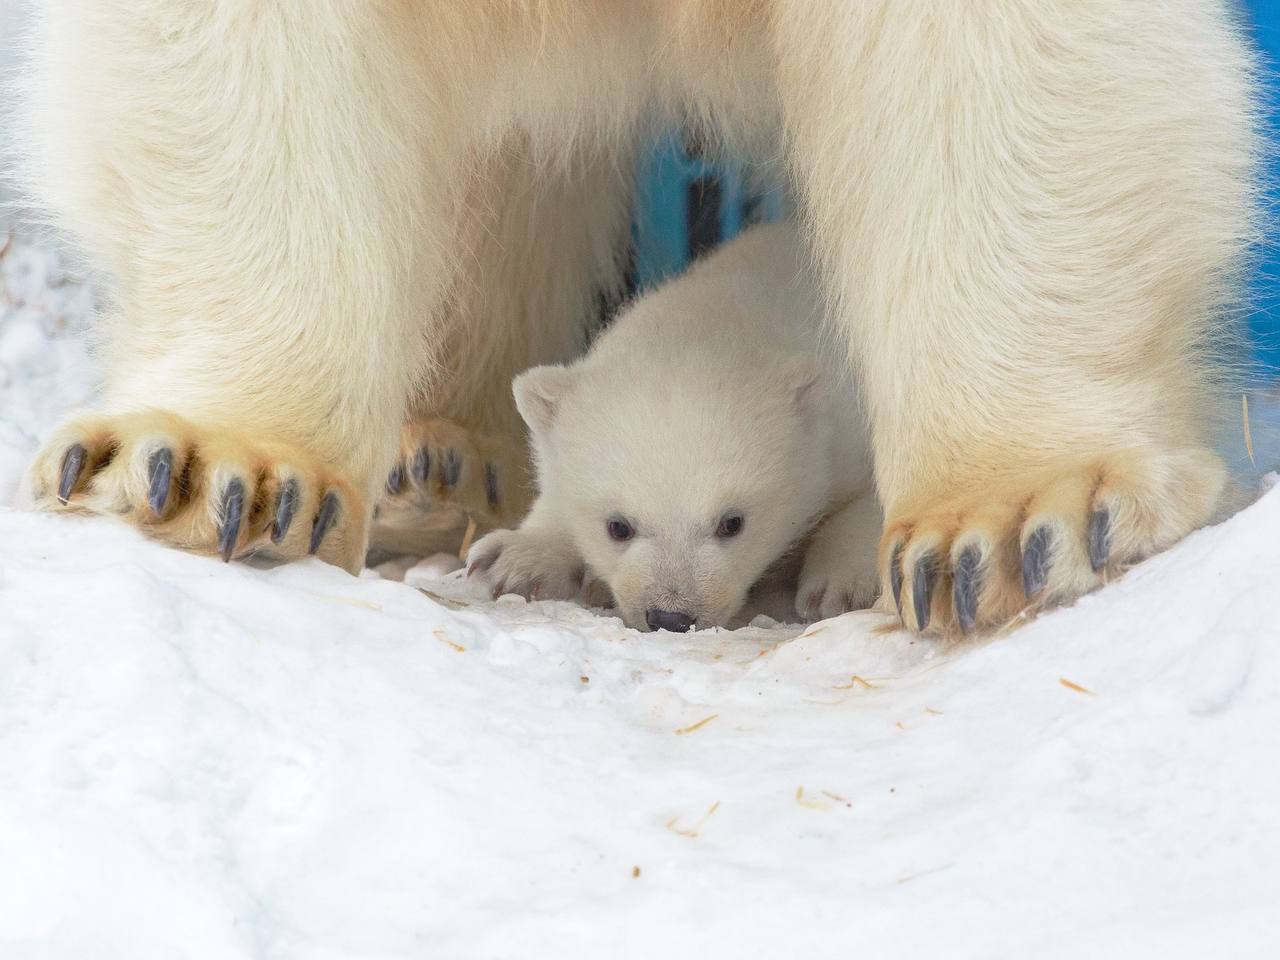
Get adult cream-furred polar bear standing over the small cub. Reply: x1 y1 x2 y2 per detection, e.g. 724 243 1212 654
17 0 1260 628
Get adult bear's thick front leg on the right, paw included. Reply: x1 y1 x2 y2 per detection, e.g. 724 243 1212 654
774 0 1258 631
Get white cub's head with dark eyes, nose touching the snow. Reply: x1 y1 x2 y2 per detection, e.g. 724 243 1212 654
513 353 831 631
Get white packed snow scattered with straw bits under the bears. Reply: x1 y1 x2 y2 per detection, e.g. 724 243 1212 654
0 241 1280 960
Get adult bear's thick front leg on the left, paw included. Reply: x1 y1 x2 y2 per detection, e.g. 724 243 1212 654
21 3 465 570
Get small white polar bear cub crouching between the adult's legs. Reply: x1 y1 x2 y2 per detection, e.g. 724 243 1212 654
467 224 882 631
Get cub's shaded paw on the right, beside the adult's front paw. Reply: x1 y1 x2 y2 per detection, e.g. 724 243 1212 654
796 497 883 620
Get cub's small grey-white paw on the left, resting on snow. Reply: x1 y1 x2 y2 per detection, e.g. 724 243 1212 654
467 530 586 600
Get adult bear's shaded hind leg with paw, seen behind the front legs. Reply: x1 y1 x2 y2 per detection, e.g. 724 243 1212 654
371 142 634 556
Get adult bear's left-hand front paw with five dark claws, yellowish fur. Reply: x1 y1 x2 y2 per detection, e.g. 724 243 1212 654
31 411 365 572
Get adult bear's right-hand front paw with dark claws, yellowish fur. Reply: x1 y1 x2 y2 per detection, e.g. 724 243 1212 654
879 447 1226 634
